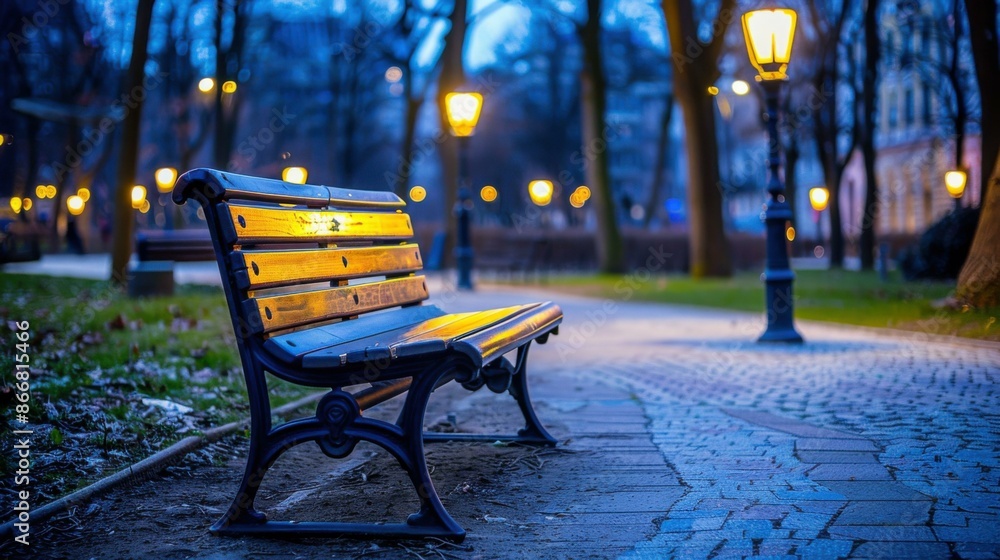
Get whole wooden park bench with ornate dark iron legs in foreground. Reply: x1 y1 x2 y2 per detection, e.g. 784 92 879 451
173 169 562 541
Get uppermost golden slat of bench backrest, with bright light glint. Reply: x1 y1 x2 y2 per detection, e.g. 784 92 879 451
222 204 413 244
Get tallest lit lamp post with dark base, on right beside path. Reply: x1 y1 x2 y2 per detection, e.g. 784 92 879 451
743 8 802 342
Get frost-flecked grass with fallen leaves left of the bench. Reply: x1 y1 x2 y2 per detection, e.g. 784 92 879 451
0 274 312 504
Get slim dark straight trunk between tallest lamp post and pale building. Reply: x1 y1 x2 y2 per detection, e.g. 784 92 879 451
860 0 881 270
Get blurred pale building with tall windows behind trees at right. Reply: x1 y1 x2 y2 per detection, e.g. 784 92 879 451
841 0 981 236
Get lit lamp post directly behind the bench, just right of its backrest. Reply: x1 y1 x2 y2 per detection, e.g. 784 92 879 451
444 92 483 290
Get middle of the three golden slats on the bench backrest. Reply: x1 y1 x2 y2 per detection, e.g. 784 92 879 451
236 243 423 289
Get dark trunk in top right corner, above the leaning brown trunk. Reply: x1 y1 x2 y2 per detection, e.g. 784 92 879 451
957 0 1000 201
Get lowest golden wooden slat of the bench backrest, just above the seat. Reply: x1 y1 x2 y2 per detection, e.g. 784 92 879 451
246 276 427 333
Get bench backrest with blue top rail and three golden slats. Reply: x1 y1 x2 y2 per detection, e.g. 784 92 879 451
173 169 428 337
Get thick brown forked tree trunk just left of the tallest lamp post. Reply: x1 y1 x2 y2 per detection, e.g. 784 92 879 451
662 0 736 278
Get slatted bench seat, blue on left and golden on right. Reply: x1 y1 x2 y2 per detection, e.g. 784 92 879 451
264 302 561 370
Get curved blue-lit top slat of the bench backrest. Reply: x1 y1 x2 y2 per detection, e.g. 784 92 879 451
173 168 406 209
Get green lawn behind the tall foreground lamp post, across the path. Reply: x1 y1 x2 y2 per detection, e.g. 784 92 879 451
528 270 1000 340
